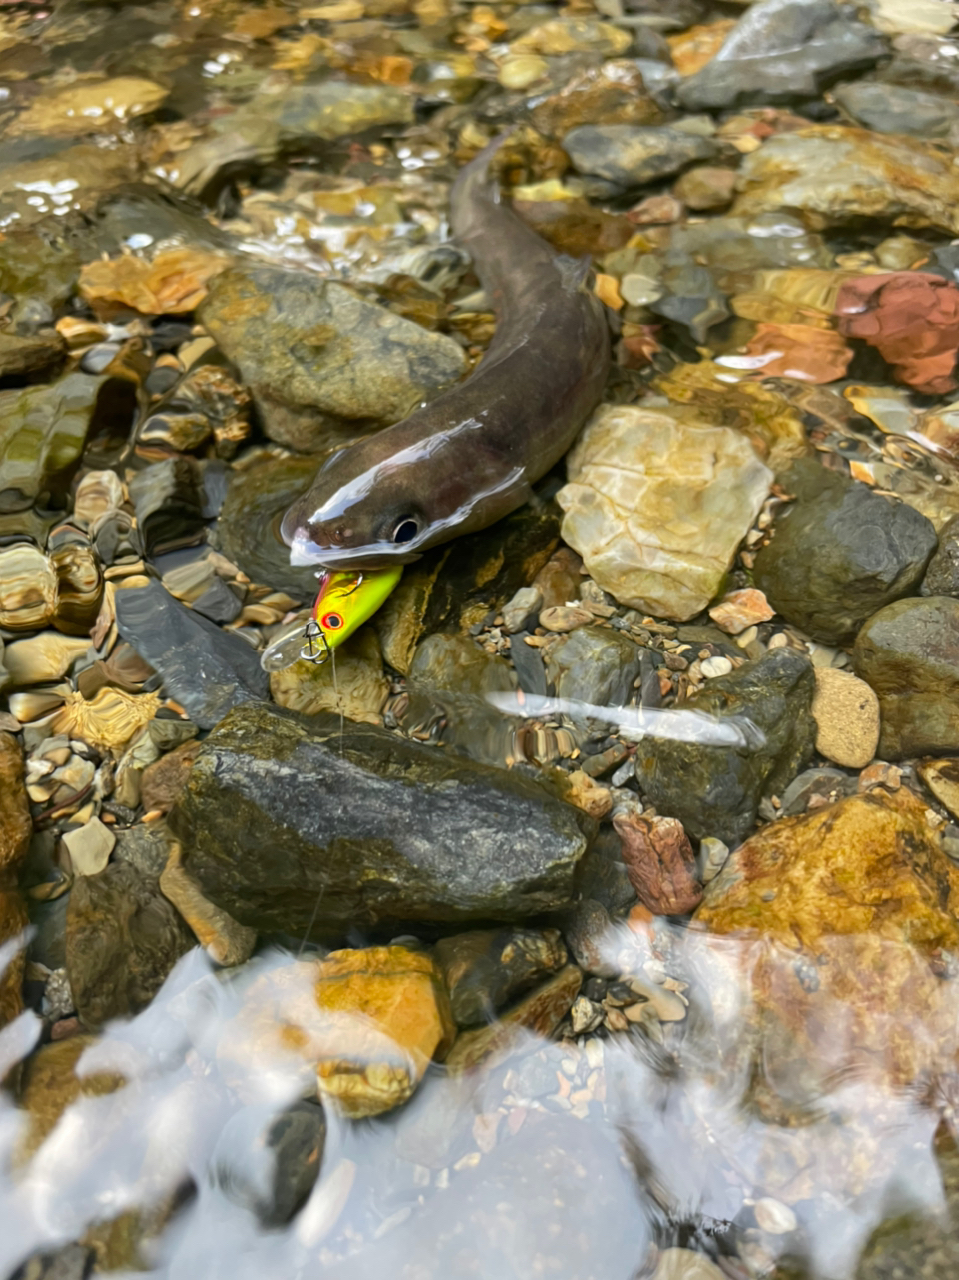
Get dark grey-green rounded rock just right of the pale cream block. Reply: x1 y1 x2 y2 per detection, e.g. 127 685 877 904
754 465 936 644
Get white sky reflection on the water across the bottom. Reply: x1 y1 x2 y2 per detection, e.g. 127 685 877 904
0 920 959 1280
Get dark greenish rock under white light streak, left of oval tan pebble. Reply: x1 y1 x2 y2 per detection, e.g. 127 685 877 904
636 649 816 845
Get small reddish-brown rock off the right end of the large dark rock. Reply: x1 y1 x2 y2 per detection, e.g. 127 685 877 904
613 813 703 915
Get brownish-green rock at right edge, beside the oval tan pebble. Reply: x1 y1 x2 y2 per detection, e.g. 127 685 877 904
853 595 959 760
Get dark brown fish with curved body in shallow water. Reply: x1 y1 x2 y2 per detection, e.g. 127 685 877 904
283 138 609 568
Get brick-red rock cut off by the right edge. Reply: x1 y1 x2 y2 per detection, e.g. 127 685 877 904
836 271 959 396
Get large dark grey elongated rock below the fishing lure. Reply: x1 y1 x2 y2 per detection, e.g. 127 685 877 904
170 703 592 940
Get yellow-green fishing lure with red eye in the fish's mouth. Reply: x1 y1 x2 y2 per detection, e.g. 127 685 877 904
260 564 403 671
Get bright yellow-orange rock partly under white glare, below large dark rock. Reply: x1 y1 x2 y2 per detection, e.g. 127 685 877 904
216 947 455 1119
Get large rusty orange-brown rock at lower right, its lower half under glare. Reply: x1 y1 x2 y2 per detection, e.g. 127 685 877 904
694 787 959 1088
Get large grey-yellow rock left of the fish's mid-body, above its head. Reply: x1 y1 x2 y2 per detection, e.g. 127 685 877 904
200 266 466 452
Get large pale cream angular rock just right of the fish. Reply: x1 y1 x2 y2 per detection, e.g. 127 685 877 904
557 404 772 622
